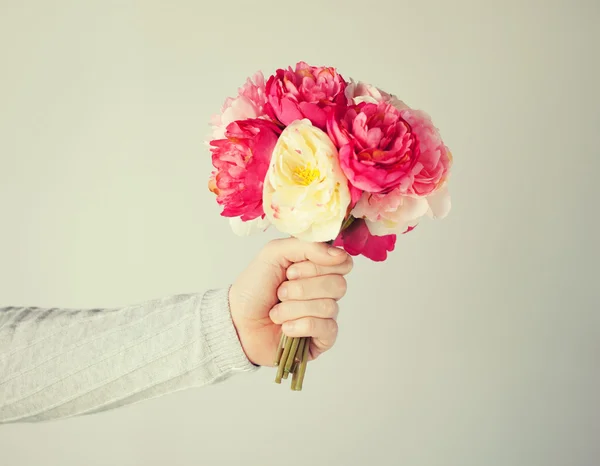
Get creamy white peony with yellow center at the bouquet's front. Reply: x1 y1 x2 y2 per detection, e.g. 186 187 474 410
263 119 350 242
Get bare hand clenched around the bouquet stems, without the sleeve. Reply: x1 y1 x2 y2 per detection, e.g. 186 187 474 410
229 238 353 366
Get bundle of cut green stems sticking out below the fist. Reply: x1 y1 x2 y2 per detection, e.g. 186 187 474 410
275 333 311 392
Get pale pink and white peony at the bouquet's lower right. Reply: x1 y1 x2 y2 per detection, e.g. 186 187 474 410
352 185 451 236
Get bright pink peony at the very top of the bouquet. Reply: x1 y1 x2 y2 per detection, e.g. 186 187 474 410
266 62 346 130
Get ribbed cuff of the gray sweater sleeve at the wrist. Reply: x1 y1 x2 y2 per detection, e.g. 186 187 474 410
200 288 258 375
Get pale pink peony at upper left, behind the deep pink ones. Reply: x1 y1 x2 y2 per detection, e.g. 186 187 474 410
212 71 267 139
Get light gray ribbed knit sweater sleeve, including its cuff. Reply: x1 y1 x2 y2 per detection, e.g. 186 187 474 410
0 289 256 423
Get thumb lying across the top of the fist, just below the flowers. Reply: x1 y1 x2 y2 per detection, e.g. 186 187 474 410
262 238 348 269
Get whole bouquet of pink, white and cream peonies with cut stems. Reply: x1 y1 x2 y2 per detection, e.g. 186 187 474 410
209 62 452 390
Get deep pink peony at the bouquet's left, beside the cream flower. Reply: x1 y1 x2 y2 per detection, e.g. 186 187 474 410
209 119 281 222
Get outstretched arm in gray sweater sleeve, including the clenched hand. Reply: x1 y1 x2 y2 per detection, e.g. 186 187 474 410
0 239 352 424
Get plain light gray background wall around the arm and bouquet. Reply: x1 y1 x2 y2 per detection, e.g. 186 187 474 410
0 0 600 466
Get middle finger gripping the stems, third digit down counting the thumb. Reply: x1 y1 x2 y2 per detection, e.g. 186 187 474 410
277 275 347 302
